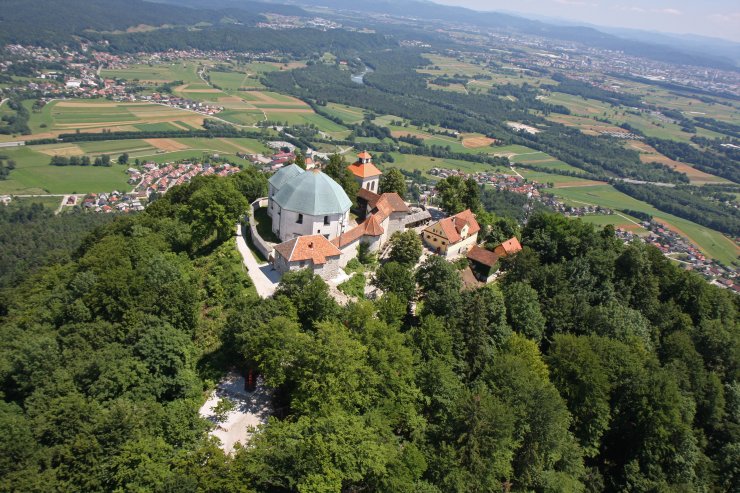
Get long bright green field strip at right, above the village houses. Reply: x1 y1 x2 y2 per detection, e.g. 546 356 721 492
551 185 740 265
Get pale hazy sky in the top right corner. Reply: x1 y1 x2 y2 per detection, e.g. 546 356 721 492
432 0 740 41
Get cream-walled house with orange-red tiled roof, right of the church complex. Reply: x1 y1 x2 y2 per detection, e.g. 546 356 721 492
422 209 480 258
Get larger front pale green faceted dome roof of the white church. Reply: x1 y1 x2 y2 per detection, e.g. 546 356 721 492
273 169 352 216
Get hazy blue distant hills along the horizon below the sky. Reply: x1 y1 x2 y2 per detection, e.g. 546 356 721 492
0 0 738 70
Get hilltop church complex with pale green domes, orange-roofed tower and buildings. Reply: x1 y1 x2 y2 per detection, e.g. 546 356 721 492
253 152 520 279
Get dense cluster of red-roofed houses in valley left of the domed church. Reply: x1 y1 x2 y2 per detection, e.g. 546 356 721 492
127 162 239 197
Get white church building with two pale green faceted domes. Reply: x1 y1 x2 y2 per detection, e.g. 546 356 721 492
267 164 352 241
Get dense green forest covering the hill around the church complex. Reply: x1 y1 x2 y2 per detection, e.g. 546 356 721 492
0 171 740 493
